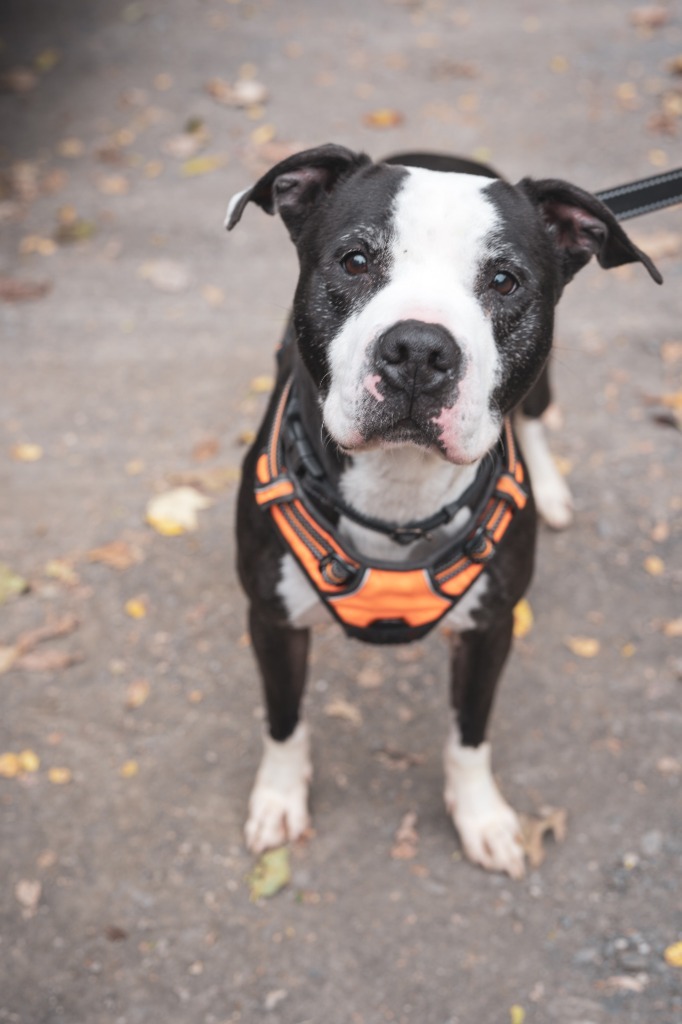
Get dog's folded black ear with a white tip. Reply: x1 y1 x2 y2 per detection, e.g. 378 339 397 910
225 143 371 242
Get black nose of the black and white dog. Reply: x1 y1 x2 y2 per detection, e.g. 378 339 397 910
376 319 462 394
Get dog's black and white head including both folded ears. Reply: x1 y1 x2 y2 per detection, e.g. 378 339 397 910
226 145 662 463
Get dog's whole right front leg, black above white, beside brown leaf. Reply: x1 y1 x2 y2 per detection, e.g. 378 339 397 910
444 612 524 879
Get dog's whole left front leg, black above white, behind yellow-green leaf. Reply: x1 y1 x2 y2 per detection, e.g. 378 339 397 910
245 607 312 853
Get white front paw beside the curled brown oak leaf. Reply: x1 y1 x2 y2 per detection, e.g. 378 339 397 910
444 734 525 879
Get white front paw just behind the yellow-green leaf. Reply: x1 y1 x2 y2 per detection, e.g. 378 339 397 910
244 722 312 853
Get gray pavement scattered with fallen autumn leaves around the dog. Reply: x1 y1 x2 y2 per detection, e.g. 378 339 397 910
0 0 682 1024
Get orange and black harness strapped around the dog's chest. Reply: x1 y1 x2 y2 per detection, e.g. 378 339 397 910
255 380 527 643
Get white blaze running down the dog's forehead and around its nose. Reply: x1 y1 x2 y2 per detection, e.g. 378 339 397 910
324 168 500 463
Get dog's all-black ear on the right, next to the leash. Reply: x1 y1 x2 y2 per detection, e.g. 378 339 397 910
518 178 663 285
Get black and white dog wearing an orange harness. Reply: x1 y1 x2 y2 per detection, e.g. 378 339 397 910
226 145 660 878
